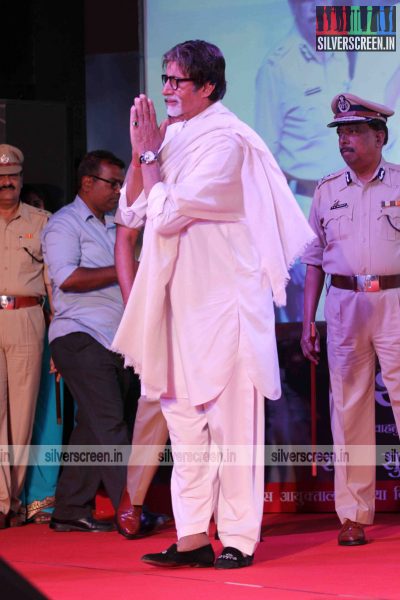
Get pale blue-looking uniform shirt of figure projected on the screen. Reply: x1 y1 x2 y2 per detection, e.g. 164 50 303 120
256 30 348 179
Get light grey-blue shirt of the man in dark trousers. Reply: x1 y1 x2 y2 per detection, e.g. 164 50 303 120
42 196 123 349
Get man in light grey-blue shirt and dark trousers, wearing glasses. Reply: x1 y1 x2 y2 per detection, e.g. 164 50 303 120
42 150 133 531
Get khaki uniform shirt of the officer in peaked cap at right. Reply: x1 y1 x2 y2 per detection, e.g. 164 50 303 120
302 159 400 275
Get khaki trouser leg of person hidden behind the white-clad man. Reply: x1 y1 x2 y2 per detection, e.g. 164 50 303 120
127 395 168 506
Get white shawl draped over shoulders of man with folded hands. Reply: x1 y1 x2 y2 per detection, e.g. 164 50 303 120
112 102 315 397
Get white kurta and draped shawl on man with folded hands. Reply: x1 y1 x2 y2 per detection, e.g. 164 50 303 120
113 103 313 405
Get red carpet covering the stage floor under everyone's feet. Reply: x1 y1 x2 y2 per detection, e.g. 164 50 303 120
0 513 400 600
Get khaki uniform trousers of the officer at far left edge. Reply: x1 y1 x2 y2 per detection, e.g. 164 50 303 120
0 305 45 514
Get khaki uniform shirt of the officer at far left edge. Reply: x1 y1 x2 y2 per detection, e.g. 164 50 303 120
0 202 50 296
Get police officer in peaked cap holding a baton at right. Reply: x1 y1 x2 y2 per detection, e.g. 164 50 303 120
301 94 400 546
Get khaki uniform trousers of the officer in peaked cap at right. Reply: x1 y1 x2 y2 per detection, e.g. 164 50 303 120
325 286 400 525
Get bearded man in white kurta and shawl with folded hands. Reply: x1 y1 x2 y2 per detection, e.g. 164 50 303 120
114 41 313 569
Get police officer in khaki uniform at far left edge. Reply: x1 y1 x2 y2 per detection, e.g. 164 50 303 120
0 144 48 529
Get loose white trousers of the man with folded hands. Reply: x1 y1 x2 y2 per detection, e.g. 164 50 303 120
161 357 264 554
